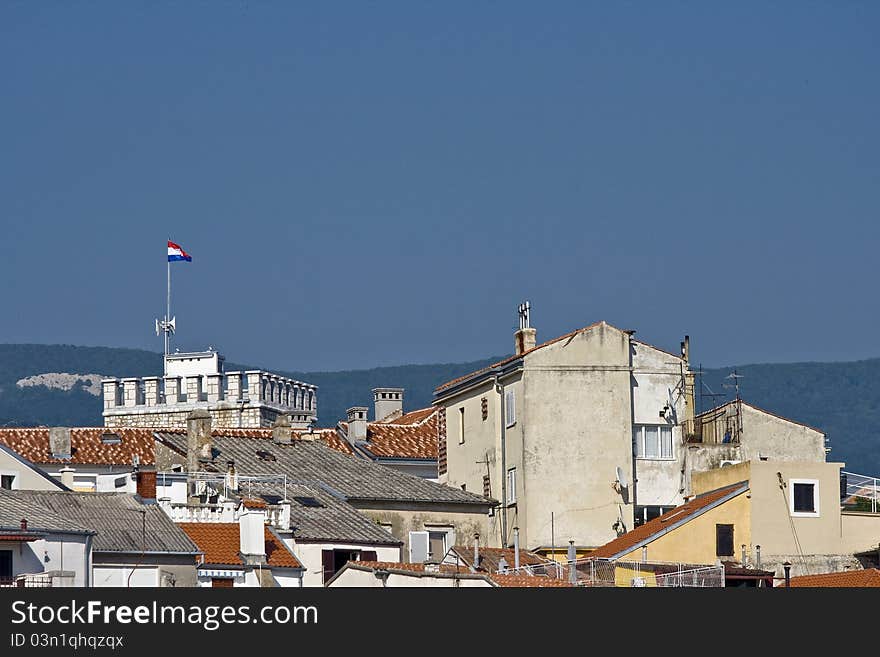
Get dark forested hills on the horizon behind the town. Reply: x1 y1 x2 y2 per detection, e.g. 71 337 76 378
0 344 880 475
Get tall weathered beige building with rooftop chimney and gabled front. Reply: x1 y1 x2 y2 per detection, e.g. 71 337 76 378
434 316 694 554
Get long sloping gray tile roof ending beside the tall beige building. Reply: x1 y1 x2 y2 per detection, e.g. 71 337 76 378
155 431 494 508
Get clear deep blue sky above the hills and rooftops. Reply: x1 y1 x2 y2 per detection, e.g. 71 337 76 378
0 2 880 370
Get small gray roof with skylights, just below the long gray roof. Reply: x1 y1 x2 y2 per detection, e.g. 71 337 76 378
287 484 400 545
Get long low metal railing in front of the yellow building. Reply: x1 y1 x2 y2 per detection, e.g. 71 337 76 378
505 558 724 588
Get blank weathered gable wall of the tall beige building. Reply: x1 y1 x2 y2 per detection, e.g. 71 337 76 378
519 324 633 549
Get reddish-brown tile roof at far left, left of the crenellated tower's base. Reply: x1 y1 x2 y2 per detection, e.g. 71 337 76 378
0 427 156 466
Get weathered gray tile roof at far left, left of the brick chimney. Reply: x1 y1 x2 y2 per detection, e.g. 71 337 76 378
7 491 199 554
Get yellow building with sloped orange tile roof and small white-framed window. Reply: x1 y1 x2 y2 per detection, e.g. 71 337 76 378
590 461 880 577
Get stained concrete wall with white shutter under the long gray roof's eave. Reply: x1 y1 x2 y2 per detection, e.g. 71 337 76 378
349 500 489 561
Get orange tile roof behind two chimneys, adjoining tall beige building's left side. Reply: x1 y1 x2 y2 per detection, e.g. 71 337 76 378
364 407 439 459
